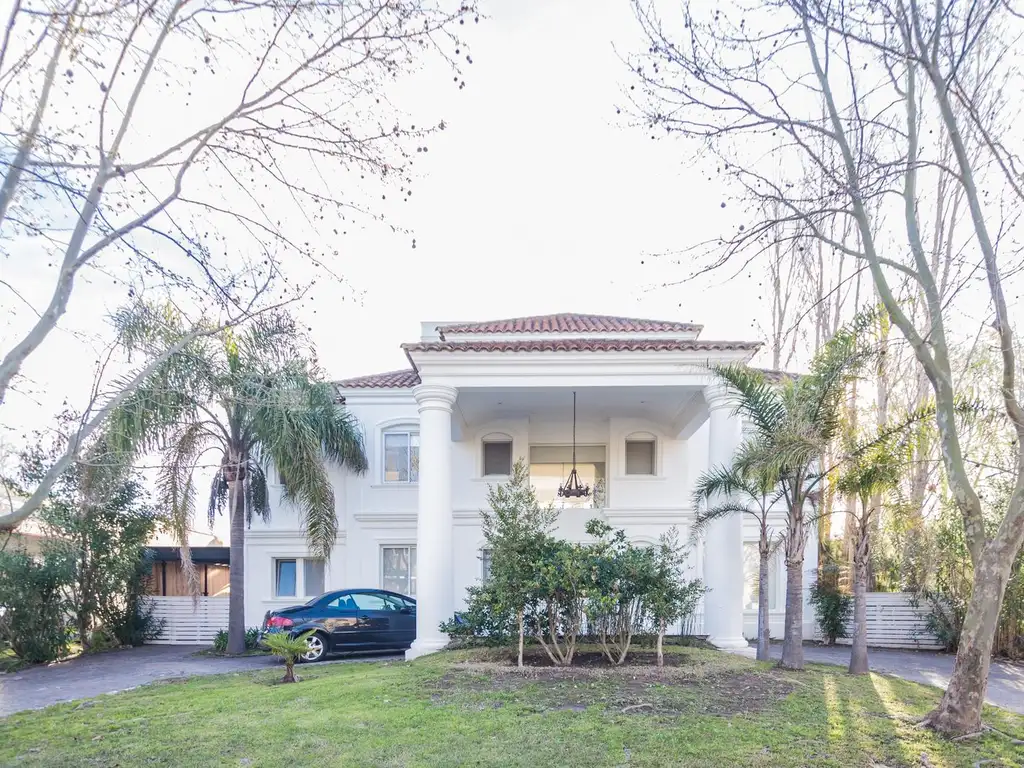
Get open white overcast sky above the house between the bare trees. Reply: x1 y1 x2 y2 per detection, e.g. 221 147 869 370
0 0 1015 540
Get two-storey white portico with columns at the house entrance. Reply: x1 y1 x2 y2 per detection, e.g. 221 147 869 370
404 324 758 658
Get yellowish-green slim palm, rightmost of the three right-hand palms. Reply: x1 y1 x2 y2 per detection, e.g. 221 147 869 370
838 439 905 675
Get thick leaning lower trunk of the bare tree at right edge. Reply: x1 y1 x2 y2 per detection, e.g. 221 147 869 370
926 536 1020 734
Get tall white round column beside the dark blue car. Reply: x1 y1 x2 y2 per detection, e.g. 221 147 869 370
406 384 458 658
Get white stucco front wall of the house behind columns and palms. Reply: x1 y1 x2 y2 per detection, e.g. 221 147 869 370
246 390 816 637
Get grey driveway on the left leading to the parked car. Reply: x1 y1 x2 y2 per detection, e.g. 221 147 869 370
0 645 401 717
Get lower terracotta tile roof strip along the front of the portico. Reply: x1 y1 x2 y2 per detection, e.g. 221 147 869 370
401 338 761 353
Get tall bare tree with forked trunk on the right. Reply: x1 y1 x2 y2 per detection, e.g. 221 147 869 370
633 0 1024 733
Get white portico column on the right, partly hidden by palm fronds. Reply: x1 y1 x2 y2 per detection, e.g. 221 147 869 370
703 384 749 648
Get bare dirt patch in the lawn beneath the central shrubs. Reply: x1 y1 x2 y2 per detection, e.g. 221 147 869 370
429 653 796 719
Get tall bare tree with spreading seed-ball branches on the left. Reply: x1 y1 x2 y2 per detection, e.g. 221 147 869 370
0 0 475 526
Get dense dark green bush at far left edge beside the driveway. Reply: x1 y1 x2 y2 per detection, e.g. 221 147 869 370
0 551 75 663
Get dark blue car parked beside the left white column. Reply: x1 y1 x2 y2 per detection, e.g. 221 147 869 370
260 590 416 662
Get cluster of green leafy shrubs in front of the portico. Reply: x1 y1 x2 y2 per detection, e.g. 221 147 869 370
448 468 703 666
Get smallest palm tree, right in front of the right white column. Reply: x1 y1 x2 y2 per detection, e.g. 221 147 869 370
690 466 783 662
